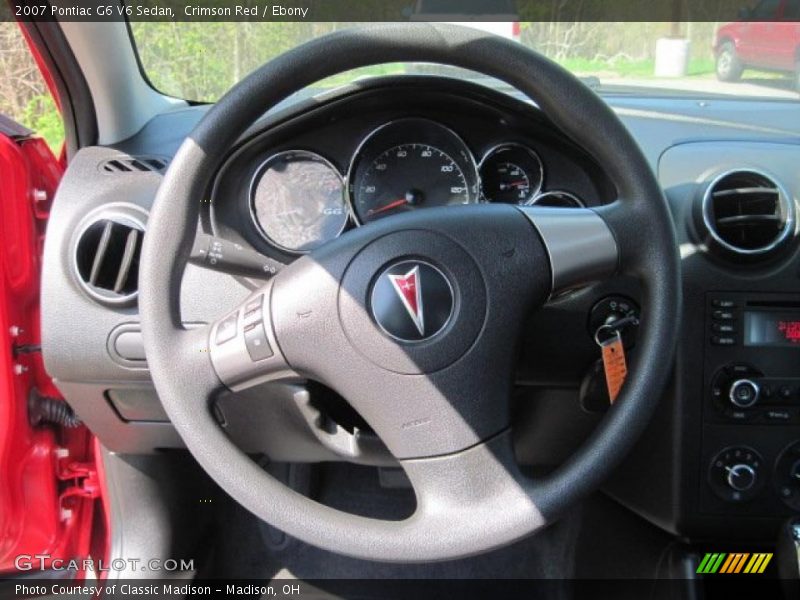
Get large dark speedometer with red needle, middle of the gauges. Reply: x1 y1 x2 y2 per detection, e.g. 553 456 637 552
348 119 477 224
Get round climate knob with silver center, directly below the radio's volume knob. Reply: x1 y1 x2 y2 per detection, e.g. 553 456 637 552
708 446 765 502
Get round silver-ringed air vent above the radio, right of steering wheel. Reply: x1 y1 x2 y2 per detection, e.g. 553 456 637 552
702 170 795 256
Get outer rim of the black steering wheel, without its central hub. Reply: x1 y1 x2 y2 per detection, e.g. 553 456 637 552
140 24 680 561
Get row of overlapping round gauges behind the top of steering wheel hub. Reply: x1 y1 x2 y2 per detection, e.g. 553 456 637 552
248 118 584 255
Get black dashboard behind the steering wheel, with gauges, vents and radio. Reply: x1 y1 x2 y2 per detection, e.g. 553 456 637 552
42 76 800 540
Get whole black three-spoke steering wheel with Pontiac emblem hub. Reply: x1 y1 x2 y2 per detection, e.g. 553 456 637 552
140 24 680 562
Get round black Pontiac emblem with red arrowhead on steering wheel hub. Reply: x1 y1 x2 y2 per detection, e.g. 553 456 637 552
370 260 455 343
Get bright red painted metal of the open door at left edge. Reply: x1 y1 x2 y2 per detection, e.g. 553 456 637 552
0 117 105 577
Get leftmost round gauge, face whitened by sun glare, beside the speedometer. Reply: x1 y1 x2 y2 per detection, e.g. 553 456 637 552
250 150 347 253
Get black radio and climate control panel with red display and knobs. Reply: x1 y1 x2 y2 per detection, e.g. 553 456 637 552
700 292 800 517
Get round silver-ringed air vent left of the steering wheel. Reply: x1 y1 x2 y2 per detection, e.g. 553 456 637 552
74 211 144 304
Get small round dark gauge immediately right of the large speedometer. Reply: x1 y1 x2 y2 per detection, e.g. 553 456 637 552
480 144 544 204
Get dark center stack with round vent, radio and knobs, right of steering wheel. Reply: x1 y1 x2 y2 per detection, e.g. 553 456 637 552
610 141 800 551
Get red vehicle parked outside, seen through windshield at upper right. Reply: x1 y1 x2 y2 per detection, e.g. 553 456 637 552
714 0 800 91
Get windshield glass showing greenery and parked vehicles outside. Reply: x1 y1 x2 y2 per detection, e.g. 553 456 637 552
131 20 800 102
